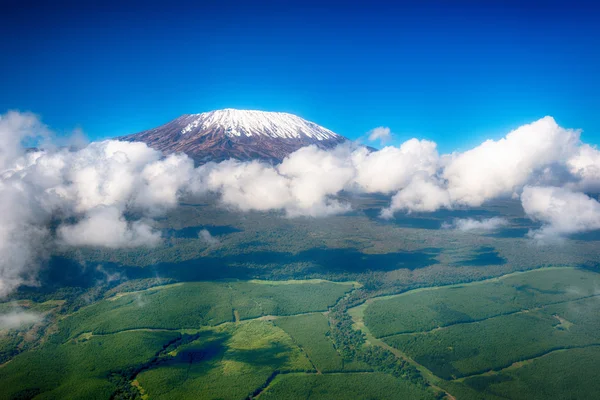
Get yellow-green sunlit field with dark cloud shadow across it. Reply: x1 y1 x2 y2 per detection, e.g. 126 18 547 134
137 321 314 399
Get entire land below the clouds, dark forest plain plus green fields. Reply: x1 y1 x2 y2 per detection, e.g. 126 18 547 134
0 195 600 399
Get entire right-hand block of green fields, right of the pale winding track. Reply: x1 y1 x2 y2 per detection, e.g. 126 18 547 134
350 268 600 399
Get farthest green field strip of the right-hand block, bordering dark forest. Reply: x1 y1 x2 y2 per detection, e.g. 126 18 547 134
364 268 600 337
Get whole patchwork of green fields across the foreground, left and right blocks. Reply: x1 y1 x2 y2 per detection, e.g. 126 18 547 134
0 253 600 400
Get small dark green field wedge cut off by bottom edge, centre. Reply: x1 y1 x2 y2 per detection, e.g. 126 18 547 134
260 372 435 400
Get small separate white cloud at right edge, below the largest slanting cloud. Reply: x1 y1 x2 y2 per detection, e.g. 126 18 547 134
521 186 600 241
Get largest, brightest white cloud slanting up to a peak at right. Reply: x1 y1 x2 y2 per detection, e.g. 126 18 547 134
383 117 600 216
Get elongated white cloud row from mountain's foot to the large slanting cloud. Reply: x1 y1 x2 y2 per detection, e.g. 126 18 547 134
190 139 439 217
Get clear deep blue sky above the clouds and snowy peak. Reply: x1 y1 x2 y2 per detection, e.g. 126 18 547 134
0 0 600 151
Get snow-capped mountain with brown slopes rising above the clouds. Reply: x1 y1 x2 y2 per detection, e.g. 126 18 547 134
120 108 348 163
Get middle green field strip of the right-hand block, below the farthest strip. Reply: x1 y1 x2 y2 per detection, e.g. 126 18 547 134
385 298 600 379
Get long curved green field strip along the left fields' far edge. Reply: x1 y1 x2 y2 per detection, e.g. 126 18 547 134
59 281 353 338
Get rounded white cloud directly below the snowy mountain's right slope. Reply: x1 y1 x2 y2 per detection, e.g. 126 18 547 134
192 146 354 217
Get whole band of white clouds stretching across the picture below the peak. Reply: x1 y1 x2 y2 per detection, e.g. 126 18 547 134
0 112 600 296
